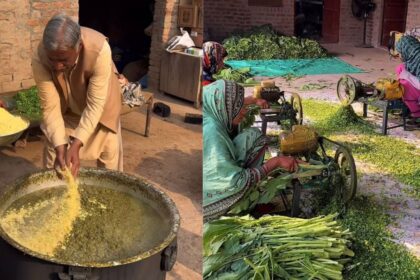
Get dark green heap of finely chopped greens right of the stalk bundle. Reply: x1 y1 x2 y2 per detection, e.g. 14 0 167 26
340 197 420 280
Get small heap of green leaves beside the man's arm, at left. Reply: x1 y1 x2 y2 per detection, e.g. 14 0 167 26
14 86 42 121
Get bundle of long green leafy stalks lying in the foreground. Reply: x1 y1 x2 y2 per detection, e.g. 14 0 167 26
203 215 354 280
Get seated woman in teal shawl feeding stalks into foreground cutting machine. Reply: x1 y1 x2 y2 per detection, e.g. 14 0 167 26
203 80 297 221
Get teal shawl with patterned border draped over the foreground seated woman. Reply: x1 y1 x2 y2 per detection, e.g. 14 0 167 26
203 80 263 218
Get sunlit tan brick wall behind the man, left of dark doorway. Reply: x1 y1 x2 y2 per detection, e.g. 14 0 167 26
0 0 79 93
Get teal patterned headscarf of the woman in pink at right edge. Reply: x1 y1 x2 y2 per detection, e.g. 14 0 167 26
396 36 420 79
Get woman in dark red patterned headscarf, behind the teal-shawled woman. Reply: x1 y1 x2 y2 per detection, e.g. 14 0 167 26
202 42 227 86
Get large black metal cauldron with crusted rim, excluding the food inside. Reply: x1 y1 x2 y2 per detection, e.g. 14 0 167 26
0 168 180 280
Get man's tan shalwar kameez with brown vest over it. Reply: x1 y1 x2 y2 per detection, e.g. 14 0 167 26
32 27 123 171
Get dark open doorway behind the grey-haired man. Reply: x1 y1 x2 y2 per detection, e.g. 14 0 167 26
79 0 155 81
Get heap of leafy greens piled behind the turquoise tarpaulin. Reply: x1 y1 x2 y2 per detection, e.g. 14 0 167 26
223 25 328 60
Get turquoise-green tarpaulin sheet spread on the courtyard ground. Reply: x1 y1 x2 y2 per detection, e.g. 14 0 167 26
226 57 363 77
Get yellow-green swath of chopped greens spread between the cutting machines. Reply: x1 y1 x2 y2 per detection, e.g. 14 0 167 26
303 99 420 197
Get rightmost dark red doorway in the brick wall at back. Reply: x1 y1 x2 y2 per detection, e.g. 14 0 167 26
381 0 408 46
